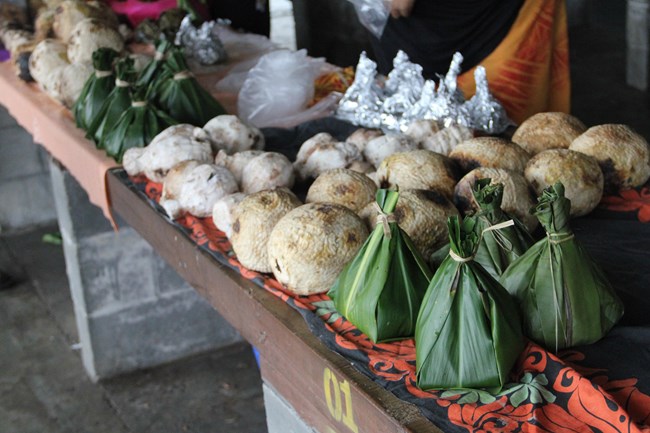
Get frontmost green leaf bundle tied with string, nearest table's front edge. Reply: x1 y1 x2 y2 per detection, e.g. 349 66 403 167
415 216 524 392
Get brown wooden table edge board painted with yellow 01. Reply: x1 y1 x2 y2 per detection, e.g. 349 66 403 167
107 169 442 433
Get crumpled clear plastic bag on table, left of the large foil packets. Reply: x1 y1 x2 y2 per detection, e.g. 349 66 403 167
238 50 324 128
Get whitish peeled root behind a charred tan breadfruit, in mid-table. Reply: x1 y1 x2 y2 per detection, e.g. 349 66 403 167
293 132 362 179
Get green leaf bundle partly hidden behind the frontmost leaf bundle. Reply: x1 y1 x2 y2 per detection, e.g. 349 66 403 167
431 179 535 279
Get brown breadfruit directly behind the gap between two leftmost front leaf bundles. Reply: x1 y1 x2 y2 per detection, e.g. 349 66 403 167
359 189 458 260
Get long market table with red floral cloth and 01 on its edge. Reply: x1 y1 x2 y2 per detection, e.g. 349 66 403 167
0 49 650 433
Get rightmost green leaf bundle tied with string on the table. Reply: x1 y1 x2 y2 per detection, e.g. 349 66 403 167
500 182 623 351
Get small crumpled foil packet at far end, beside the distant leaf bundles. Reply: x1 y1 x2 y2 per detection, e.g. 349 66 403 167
175 15 228 65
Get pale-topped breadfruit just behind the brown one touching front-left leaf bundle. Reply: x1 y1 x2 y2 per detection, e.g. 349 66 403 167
377 149 456 198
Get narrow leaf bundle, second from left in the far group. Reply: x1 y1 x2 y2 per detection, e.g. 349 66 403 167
86 57 137 148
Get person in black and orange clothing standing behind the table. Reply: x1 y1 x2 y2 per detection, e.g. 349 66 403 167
372 0 571 123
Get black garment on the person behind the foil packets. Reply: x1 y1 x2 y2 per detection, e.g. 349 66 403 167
371 0 524 79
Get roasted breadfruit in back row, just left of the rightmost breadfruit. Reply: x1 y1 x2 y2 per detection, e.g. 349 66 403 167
512 112 587 155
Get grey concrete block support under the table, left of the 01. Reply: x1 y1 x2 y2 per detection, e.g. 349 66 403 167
50 162 241 380
